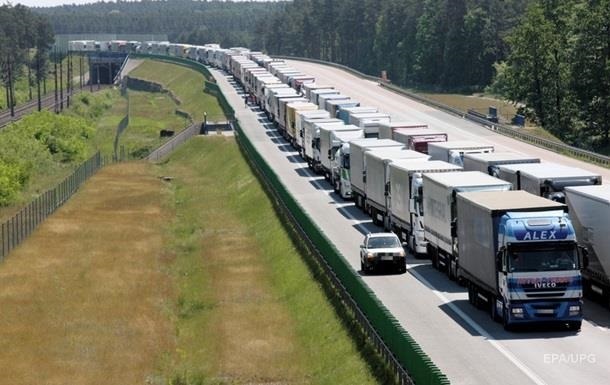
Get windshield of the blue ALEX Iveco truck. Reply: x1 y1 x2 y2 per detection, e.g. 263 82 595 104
508 246 579 273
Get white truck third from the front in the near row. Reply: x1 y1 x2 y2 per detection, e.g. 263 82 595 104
388 160 462 257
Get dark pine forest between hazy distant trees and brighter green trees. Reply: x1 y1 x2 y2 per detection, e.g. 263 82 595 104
257 0 527 90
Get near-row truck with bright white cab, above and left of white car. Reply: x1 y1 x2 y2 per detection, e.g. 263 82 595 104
330 126 364 195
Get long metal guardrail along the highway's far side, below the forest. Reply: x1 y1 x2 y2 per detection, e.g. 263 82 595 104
274 56 610 168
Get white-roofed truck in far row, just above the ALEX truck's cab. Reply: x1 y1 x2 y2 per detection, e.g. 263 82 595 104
498 162 602 203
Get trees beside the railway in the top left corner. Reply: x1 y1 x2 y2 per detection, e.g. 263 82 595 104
0 4 54 111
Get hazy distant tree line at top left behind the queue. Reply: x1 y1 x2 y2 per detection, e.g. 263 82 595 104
35 0 282 47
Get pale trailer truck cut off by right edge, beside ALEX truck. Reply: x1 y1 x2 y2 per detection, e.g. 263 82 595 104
565 185 610 306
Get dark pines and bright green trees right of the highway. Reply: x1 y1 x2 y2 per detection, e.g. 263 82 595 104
256 0 610 152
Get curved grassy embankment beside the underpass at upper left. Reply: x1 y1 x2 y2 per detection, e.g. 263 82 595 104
129 60 224 122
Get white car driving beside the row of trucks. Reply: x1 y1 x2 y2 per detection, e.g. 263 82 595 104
360 233 407 274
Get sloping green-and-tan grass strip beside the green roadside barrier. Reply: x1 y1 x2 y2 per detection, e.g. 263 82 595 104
158 137 387 384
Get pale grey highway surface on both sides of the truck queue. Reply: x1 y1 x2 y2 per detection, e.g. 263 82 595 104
207 61 610 385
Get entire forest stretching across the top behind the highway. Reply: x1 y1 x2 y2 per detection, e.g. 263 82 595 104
17 0 610 153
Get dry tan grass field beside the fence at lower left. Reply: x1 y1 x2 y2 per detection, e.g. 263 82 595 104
0 164 174 385
